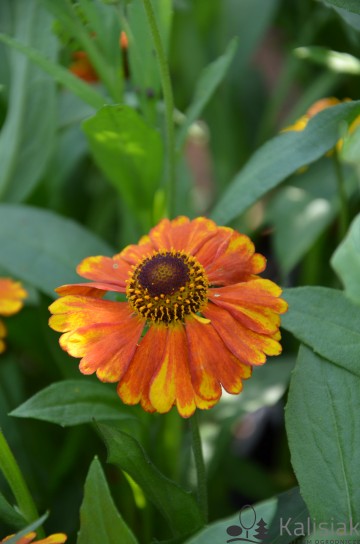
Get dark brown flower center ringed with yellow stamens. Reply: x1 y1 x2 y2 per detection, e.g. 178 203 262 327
126 250 208 324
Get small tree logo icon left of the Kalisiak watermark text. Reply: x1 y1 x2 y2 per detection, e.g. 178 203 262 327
226 504 268 544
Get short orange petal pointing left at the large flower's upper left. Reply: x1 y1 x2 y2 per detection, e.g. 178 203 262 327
76 255 130 291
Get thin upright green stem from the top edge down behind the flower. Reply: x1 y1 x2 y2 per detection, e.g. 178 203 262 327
142 0 176 217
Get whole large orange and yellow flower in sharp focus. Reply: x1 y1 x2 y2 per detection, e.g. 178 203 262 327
49 217 287 417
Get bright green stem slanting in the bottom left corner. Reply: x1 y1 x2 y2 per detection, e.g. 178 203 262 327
0 431 45 538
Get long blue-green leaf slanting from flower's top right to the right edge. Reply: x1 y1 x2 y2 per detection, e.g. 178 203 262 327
212 101 360 224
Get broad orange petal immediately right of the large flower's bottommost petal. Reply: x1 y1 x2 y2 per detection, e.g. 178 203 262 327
186 319 251 398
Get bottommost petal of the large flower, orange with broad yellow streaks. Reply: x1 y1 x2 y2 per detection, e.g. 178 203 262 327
149 324 196 417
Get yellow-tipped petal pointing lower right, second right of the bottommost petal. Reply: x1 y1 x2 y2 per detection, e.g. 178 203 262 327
204 302 281 365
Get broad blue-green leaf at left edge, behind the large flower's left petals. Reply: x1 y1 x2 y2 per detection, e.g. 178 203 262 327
0 204 114 298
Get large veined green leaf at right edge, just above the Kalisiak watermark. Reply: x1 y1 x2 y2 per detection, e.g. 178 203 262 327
286 341 360 524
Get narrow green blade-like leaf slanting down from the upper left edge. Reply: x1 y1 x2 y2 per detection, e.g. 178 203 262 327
0 31 108 109
